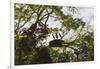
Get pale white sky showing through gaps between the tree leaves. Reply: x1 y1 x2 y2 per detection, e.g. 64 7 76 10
43 7 94 43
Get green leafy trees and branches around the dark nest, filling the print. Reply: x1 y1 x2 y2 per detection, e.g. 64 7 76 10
14 3 94 65
